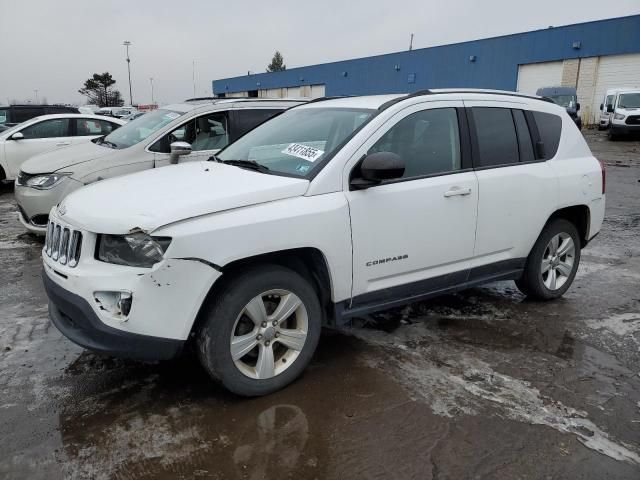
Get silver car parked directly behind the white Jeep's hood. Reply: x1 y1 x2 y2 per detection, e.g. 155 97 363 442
15 100 301 234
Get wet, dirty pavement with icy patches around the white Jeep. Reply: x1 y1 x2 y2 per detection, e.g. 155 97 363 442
0 132 640 480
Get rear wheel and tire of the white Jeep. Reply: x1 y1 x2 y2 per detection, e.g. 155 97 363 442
516 218 580 300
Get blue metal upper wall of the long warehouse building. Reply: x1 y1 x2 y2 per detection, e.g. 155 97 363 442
213 15 640 95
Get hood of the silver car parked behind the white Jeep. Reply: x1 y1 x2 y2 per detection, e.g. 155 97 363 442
20 142 122 175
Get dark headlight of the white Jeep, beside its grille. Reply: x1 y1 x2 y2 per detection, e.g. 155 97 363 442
98 233 171 268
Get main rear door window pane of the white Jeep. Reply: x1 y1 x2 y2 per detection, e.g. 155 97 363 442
471 107 519 168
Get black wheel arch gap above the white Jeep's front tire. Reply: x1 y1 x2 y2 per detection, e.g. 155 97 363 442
191 247 334 336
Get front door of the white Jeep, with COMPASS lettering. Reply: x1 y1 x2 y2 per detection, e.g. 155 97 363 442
347 102 478 306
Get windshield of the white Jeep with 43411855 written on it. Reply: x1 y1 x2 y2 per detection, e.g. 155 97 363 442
218 108 374 177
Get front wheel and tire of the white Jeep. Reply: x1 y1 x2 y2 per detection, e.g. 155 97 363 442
197 265 322 397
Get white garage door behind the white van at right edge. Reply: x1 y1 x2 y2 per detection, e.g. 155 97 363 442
591 53 640 117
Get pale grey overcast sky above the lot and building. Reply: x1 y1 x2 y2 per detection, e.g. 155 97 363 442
0 0 640 104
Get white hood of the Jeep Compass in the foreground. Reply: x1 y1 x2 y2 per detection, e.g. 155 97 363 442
58 162 309 234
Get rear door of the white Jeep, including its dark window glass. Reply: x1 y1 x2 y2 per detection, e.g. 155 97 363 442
464 101 560 274
